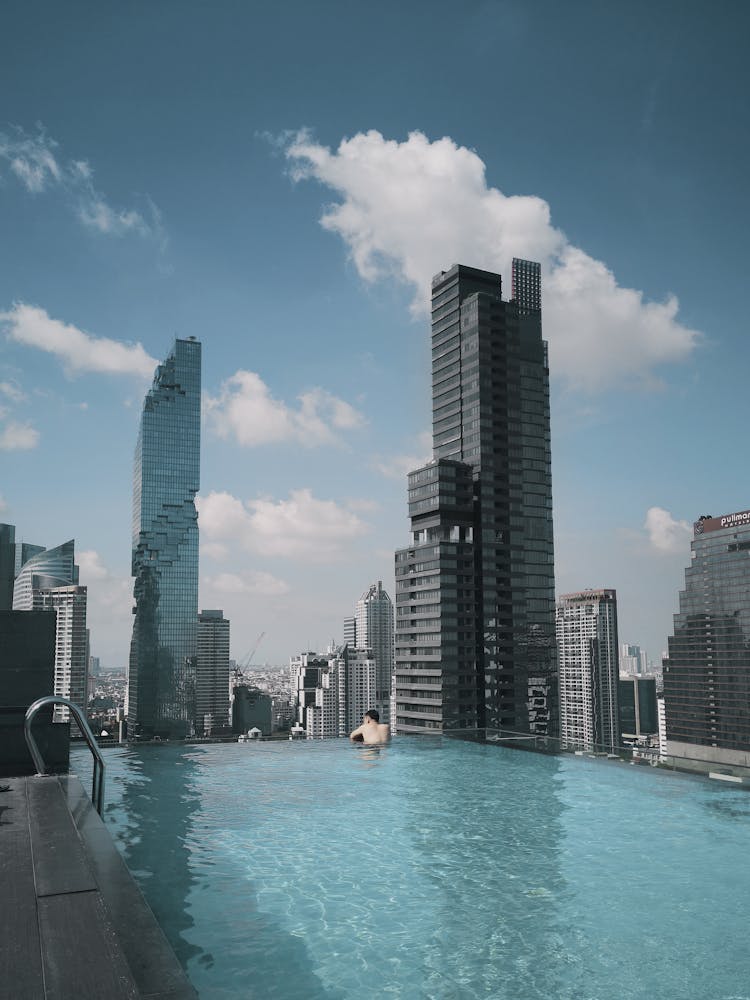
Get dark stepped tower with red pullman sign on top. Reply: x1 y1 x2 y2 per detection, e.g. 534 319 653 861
664 511 750 764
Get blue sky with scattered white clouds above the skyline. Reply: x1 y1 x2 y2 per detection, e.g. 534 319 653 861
0 0 750 668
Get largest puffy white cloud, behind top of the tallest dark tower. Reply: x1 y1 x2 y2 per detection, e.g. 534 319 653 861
286 131 700 391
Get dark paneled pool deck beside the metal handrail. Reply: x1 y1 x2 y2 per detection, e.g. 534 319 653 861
0 775 196 1000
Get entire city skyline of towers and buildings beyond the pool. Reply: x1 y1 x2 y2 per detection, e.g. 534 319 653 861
0 259 750 769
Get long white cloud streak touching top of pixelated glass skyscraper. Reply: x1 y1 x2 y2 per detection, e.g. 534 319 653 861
0 302 157 378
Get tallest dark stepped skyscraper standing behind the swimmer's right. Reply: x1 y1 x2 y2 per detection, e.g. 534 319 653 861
394 260 557 735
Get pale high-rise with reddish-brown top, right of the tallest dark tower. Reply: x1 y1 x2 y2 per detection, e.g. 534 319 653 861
556 590 621 752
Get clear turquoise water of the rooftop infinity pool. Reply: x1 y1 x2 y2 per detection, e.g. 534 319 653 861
75 737 750 1000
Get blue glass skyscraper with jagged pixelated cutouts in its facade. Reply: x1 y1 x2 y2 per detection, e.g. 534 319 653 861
128 338 201 739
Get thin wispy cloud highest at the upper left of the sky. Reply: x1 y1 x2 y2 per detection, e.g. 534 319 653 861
0 126 165 246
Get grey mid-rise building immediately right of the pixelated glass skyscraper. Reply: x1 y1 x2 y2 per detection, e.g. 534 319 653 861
195 611 230 736
